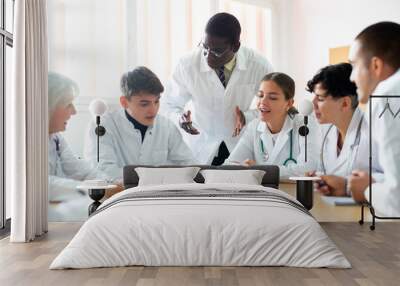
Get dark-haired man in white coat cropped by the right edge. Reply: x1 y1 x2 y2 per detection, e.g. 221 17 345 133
349 22 400 216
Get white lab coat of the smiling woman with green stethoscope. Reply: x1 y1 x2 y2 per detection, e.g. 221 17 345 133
226 115 320 179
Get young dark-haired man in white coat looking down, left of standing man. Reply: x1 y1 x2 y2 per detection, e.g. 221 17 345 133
85 67 196 180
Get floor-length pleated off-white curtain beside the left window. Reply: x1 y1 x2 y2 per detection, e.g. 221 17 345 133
6 0 48 242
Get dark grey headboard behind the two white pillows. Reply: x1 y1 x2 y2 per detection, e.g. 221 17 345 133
124 165 279 189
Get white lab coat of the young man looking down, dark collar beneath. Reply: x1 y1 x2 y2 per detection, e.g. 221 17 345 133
84 109 197 180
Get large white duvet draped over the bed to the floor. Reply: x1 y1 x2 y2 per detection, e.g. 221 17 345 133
50 184 351 269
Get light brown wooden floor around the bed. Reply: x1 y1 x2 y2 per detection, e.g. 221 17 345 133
0 222 400 286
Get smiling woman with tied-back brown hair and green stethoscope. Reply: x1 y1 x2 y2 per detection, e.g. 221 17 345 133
227 72 319 179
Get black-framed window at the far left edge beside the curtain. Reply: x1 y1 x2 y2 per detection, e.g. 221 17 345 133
0 0 14 232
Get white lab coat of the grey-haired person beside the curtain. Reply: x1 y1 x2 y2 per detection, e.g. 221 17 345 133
49 133 109 201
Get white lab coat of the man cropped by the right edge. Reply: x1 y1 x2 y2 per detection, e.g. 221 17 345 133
365 69 400 217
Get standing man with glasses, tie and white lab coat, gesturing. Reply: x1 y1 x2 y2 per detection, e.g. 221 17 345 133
162 13 272 165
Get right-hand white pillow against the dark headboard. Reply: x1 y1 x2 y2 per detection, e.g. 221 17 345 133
200 170 265 185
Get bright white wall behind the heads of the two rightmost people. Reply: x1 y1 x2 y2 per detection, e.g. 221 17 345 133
281 0 400 99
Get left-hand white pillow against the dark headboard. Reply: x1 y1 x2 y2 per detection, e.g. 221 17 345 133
135 167 200 186
